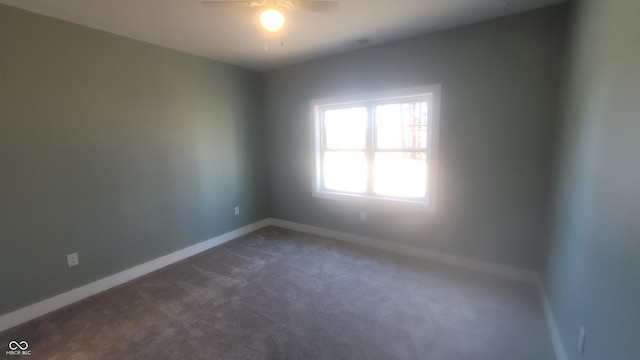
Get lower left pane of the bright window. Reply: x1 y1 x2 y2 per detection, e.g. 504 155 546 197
323 151 367 193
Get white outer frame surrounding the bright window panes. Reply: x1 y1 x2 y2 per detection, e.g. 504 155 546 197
310 84 441 210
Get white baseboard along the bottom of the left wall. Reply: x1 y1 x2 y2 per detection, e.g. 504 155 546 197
0 219 270 331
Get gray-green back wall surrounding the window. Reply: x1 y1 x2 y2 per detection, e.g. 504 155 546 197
265 6 567 270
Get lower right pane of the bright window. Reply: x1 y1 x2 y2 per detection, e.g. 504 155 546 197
373 152 428 198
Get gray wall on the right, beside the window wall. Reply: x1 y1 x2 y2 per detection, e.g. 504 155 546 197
546 0 640 360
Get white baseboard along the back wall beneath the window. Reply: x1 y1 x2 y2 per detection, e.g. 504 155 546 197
271 219 538 283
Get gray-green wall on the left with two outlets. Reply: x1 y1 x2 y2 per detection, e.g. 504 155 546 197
0 5 268 314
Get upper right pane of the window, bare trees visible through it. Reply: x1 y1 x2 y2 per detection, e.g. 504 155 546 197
375 101 429 149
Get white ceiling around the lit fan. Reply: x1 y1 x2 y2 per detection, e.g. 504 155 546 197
0 0 566 70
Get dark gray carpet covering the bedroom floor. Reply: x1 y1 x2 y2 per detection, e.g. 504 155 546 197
0 227 554 360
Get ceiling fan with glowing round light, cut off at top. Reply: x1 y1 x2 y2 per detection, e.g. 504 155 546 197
202 0 340 32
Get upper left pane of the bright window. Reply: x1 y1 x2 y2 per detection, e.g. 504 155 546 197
324 107 367 150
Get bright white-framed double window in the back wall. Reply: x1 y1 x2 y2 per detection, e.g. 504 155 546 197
311 85 440 208
